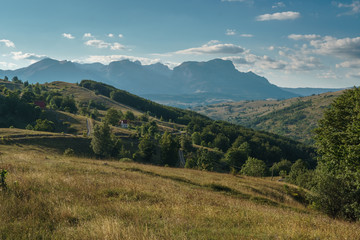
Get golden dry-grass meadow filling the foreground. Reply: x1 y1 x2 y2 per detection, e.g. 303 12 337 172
0 144 360 239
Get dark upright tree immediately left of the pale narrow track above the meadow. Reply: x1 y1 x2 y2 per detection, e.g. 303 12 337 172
160 132 179 166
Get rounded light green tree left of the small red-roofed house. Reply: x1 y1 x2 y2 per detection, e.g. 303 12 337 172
90 122 114 157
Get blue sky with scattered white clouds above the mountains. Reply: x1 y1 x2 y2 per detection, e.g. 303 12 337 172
0 0 360 88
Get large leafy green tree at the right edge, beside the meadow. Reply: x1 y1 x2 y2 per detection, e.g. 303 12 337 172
313 88 360 220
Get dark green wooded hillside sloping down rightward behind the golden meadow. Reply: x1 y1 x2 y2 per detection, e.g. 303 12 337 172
1 80 316 176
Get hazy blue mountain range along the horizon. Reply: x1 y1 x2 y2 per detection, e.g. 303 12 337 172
0 58 344 107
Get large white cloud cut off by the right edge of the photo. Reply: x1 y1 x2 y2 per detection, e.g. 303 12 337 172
310 36 360 59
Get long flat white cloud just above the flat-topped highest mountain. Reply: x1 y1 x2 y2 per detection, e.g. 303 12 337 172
175 40 244 55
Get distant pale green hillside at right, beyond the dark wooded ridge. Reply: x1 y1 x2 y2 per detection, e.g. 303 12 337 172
193 91 343 143
